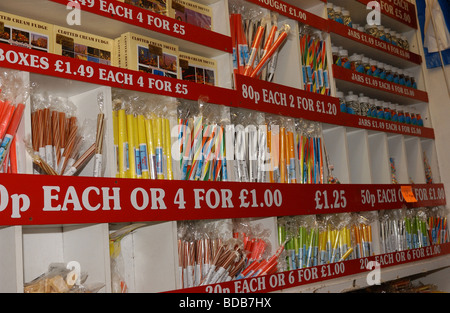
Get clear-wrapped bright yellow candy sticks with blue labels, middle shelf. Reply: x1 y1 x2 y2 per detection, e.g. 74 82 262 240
113 90 178 180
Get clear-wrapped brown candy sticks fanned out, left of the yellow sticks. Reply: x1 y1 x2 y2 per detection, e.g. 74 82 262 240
28 86 96 176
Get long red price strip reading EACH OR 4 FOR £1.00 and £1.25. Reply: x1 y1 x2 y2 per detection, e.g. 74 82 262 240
0 174 446 225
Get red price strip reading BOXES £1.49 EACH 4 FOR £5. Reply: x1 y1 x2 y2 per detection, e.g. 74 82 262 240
0 44 235 104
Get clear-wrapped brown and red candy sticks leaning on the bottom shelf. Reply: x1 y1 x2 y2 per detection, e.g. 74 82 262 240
178 218 284 288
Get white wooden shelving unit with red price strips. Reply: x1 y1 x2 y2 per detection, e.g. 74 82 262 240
0 0 450 292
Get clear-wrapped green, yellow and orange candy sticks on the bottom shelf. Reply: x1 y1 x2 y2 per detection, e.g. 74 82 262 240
278 212 366 271
